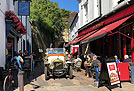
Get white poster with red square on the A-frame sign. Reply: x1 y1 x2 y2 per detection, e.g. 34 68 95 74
107 62 120 85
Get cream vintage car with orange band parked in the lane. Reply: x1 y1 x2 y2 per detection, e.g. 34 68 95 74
44 48 73 80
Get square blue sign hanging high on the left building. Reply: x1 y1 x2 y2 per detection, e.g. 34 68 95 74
18 2 30 16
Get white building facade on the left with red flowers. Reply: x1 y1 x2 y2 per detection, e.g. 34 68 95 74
0 0 32 69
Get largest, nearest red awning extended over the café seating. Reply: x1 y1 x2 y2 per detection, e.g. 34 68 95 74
83 15 132 41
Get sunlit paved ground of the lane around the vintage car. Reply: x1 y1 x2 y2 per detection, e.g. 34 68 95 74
0 63 134 91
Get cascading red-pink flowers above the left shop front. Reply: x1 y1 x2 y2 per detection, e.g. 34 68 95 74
5 11 27 34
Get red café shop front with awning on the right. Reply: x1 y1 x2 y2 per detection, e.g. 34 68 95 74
75 4 134 62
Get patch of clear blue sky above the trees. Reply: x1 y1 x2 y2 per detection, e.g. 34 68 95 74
50 0 79 12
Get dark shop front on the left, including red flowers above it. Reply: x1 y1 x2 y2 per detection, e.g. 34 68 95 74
5 11 27 68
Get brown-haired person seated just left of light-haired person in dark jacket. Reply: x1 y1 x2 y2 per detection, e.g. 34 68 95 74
84 54 92 78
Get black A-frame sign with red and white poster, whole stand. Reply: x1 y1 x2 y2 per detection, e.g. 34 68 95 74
98 58 122 91
